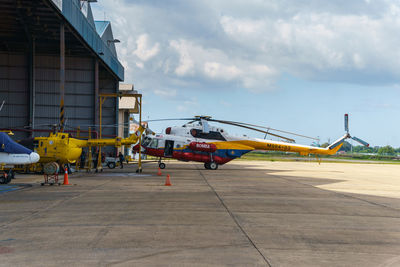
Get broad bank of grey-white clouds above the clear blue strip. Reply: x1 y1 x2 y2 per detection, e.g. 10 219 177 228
92 0 400 94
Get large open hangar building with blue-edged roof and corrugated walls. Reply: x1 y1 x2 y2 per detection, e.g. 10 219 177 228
0 0 124 138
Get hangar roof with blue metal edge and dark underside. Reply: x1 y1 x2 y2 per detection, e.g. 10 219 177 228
0 0 124 80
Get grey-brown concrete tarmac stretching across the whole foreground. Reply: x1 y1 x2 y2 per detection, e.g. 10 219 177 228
0 161 400 266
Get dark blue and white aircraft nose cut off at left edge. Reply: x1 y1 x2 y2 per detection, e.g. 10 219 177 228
0 132 40 184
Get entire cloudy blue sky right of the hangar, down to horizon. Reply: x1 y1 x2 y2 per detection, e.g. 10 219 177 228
92 0 400 147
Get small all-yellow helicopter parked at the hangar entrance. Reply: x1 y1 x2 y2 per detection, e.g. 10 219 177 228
20 126 145 168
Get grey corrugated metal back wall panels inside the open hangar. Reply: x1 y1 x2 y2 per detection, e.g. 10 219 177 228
0 53 118 138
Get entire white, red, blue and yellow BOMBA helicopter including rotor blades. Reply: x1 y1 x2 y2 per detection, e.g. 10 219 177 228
133 114 369 170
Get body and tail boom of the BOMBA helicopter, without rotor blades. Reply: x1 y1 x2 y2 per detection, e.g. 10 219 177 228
134 123 344 169
